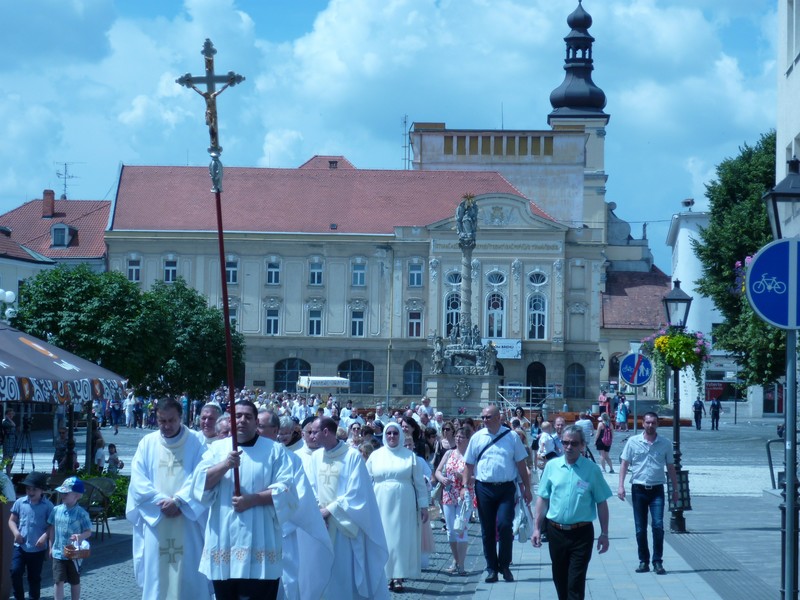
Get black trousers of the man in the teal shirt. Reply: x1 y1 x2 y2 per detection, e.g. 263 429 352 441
547 522 594 600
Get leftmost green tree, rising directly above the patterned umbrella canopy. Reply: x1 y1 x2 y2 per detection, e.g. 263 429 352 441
12 265 141 375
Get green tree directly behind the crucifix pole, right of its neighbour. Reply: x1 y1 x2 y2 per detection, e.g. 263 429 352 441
136 278 244 397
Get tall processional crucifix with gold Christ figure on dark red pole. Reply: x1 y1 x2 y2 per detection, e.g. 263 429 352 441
175 38 244 496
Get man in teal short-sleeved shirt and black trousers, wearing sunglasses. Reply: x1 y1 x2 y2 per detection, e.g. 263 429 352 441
531 425 611 600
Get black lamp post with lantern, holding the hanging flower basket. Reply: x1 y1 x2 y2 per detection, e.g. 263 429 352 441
662 279 692 533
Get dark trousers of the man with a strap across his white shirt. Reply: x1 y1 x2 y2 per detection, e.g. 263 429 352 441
475 481 515 572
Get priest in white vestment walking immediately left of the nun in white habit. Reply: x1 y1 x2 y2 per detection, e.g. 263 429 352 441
311 417 389 600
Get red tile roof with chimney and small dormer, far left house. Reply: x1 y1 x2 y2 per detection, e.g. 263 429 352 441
0 200 111 260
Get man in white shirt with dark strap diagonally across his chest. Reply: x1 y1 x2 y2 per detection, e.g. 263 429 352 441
462 404 533 583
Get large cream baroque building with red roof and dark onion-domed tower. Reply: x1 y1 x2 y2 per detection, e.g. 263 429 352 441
106 4 669 409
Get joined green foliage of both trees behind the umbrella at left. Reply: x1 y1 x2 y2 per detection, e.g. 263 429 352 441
13 265 244 397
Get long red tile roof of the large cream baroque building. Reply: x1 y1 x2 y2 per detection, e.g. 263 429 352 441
111 163 552 233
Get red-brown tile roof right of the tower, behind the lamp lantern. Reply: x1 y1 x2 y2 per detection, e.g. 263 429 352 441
601 266 671 331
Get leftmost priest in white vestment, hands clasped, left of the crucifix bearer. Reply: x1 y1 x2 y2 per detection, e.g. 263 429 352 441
125 399 211 600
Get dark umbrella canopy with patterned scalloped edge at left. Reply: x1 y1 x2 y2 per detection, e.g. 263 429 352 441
0 324 125 404
